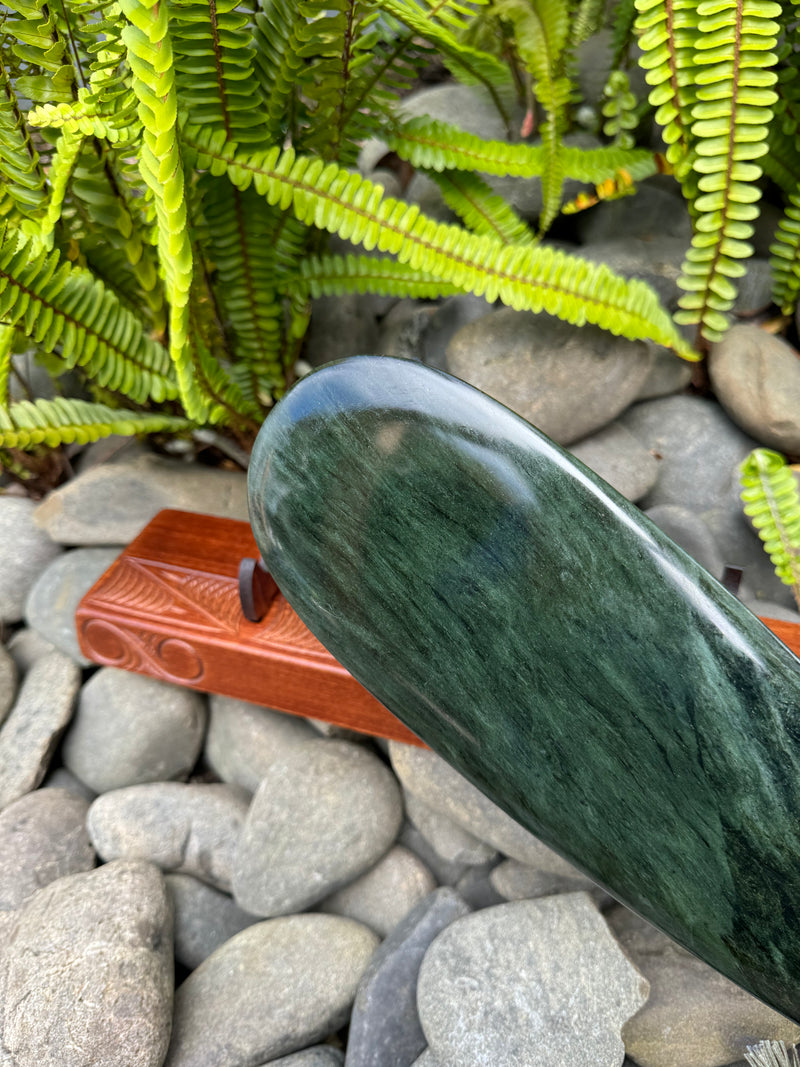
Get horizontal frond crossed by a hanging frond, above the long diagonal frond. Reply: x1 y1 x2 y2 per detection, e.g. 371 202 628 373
386 115 658 185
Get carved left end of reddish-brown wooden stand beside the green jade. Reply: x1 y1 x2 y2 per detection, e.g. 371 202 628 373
76 511 421 745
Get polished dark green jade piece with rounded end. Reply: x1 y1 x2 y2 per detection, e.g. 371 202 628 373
250 356 800 1021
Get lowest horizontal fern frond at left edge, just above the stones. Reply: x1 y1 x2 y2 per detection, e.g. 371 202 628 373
0 397 191 450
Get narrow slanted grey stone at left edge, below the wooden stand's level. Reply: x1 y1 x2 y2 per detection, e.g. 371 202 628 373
0 652 80 810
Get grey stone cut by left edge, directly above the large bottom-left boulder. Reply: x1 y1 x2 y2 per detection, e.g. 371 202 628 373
0 790 95 911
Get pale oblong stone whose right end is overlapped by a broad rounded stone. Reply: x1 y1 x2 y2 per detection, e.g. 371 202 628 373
86 782 247 892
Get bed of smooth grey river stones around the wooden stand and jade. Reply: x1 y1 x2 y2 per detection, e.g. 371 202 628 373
0 77 800 1067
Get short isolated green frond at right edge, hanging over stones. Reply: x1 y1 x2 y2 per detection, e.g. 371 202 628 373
739 448 800 606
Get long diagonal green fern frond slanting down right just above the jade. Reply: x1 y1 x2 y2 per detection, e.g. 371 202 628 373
183 127 694 359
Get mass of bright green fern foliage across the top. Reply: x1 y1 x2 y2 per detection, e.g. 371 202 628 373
0 0 800 450
